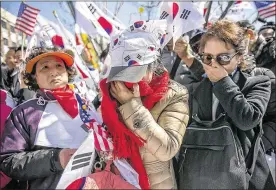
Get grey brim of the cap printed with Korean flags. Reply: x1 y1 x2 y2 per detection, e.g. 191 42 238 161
107 65 148 83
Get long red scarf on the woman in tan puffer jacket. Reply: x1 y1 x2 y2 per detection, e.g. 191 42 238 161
100 72 169 189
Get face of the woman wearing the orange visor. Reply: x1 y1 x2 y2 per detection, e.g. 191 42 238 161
35 56 68 90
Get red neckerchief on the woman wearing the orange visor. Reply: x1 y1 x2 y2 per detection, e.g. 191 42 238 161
43 85 79 118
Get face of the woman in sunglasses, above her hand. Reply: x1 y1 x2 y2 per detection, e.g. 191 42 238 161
203 38 241 74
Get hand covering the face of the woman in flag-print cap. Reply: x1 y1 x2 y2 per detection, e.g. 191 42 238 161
110 81 140 104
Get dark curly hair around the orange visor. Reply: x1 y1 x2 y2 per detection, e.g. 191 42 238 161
23 48 77 91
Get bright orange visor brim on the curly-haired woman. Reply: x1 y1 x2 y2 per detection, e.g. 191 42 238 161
26 52 74 73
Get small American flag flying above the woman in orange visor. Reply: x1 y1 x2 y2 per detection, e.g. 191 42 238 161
15 2 40 36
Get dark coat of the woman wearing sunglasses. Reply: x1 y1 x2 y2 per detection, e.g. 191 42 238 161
186 61 275 189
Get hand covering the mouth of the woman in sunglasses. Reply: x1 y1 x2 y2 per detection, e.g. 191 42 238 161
203 61 228 82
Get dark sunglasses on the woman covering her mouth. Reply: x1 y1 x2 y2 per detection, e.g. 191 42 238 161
200 52 238 65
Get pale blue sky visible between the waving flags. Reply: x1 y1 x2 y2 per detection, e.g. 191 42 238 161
1 0 273 33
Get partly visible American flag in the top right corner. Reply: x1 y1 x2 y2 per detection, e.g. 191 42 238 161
255 1 276 18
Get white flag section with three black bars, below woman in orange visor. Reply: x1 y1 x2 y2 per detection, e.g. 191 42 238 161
56 131 96 189
